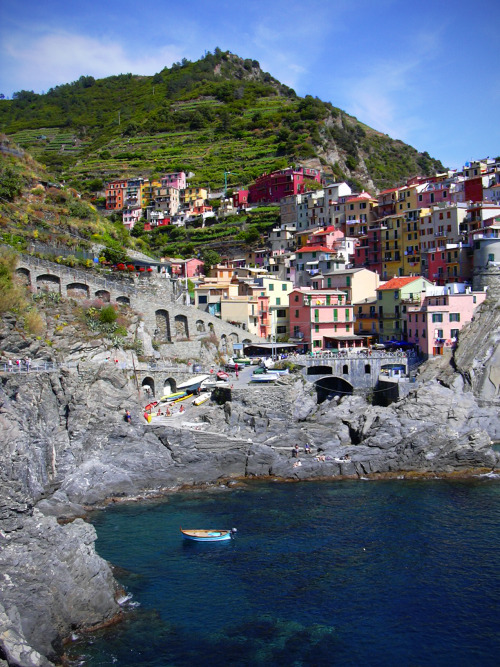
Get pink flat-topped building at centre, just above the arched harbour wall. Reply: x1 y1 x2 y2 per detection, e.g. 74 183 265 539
289 288 365 352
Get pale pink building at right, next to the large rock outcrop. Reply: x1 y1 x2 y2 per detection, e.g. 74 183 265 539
407 285 486 356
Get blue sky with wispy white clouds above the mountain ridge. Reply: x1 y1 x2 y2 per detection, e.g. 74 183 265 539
0 0 500 168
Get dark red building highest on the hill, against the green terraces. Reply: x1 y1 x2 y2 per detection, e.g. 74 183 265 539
248 167 321 204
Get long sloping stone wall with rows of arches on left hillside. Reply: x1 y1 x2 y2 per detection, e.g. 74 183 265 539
16 254 260 353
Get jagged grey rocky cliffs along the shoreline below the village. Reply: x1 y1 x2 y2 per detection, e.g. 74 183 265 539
0 298 500 665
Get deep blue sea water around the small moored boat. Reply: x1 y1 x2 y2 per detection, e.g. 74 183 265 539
70 478 500 667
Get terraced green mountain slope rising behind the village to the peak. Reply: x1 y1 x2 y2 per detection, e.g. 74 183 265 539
0 49 443 191
